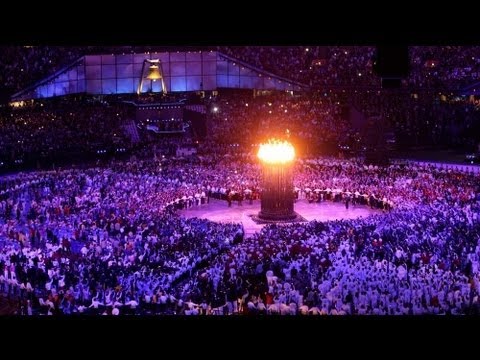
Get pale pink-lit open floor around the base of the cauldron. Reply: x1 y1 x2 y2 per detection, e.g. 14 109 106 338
179 199 382 236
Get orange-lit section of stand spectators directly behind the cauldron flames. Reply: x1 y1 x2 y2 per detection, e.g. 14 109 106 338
209 93 352 154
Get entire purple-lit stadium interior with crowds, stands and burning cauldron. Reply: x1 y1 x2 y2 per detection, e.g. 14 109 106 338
0 46 480 316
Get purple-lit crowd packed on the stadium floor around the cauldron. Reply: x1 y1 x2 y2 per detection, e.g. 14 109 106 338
0 153 480 315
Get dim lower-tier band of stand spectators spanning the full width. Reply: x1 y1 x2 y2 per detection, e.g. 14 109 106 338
0 90 480 174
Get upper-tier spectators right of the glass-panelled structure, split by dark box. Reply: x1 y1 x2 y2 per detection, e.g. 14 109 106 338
219 46 480 91
